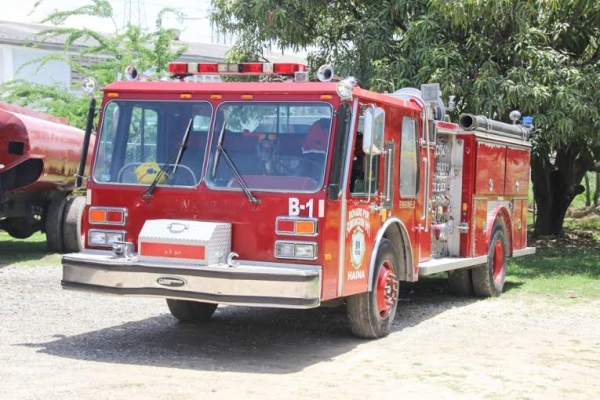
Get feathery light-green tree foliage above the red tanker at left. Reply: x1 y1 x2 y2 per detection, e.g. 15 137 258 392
0 0 187 128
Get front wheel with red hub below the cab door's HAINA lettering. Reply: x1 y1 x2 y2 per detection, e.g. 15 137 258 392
346 239 399 339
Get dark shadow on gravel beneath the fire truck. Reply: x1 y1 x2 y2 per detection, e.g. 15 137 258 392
20 283 477 374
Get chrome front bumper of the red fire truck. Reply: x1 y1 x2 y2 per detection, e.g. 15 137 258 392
61 250 321 308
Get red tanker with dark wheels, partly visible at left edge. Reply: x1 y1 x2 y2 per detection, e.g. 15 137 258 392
0 102 93 252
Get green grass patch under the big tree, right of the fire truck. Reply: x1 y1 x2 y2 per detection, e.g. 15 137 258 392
506 217 600 298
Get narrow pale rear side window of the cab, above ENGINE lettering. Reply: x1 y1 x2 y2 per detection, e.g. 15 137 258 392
400 117 419 197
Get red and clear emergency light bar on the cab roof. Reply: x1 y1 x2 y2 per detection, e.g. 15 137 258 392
169 63 306 76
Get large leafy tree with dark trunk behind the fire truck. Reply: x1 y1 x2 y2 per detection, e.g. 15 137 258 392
212 0 600 235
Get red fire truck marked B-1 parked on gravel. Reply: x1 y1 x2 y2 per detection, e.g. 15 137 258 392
62 63 534 338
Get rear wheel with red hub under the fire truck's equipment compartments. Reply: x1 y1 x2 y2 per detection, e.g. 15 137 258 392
471 221 508 297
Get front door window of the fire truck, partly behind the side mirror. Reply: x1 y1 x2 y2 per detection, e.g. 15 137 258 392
350 108 385 196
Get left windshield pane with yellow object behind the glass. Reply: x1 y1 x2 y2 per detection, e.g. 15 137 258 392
92 100 212 186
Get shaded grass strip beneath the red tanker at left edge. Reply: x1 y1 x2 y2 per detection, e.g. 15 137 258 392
0 232 61 267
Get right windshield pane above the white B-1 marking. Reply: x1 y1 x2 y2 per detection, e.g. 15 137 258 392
206 102 332 192
